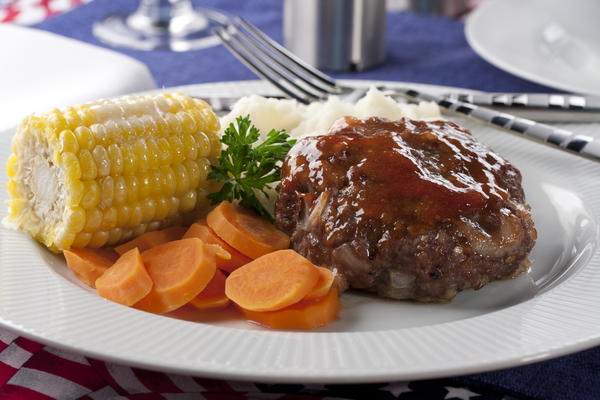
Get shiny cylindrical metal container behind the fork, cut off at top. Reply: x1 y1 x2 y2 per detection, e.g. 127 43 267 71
283 0 386 71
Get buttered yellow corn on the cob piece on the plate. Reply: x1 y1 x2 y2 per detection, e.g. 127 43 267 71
6 94 220 251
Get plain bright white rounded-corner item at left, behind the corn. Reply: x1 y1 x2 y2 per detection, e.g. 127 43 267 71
0 24 156 129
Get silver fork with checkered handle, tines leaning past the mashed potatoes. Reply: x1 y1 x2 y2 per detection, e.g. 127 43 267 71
215 17 600 161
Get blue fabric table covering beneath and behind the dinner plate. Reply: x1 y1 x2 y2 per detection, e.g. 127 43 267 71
36 0 600 400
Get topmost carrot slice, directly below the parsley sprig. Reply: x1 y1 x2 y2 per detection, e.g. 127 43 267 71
206 201 290 258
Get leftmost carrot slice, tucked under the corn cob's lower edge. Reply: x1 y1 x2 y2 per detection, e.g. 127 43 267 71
63 248 119 287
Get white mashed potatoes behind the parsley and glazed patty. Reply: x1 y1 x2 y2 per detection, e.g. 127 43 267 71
221 88 441 138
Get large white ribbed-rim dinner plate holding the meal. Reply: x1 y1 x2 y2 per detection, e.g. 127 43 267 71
0 81 600 383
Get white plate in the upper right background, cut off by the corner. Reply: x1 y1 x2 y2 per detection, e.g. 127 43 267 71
465 0 600 95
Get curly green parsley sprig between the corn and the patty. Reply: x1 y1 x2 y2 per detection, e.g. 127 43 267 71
208 116 296 222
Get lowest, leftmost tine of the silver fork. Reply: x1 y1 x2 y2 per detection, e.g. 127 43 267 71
214 27 317 104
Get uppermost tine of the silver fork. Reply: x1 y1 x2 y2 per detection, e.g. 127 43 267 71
231 24 340 98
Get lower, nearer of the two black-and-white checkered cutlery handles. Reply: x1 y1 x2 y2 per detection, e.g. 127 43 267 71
395 89 600 161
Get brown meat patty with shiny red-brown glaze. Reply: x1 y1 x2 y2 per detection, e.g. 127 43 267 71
275 117 536 301
